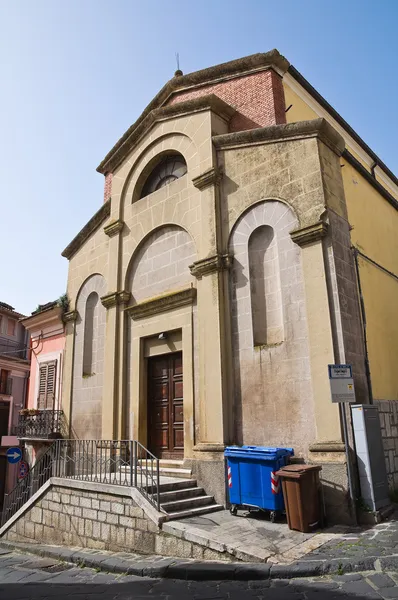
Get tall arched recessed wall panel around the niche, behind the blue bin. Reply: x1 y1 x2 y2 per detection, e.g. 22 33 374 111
230 200 315 457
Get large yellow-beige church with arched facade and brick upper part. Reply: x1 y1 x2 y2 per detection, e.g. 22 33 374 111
57 50 398 521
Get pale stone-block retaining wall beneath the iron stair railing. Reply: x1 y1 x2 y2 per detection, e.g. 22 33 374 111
0 478 236 561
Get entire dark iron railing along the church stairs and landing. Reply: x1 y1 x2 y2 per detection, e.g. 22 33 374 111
1 440 160 525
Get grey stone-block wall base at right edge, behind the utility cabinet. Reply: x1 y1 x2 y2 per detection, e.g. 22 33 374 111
374 400 398 491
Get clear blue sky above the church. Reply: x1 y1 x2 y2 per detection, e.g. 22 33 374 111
0 0 398 314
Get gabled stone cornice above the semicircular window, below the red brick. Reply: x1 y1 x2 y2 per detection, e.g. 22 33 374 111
97 94 236 175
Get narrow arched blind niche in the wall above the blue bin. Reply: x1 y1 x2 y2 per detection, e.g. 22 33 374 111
249 225 283 346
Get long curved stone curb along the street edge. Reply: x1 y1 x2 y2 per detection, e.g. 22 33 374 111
0 541 398 581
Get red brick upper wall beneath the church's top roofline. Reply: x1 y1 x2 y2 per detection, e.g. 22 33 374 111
168 69 286 132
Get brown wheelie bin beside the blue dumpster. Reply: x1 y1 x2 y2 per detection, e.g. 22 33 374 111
276 465 323 533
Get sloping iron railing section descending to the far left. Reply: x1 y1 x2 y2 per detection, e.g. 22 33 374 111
1 442 56 526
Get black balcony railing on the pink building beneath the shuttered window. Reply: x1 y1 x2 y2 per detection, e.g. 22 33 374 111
13 410 66 440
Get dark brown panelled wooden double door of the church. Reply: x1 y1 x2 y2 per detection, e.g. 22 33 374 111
148 352 184 458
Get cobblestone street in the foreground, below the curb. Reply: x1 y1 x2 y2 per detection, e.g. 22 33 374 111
0 552 398 600
